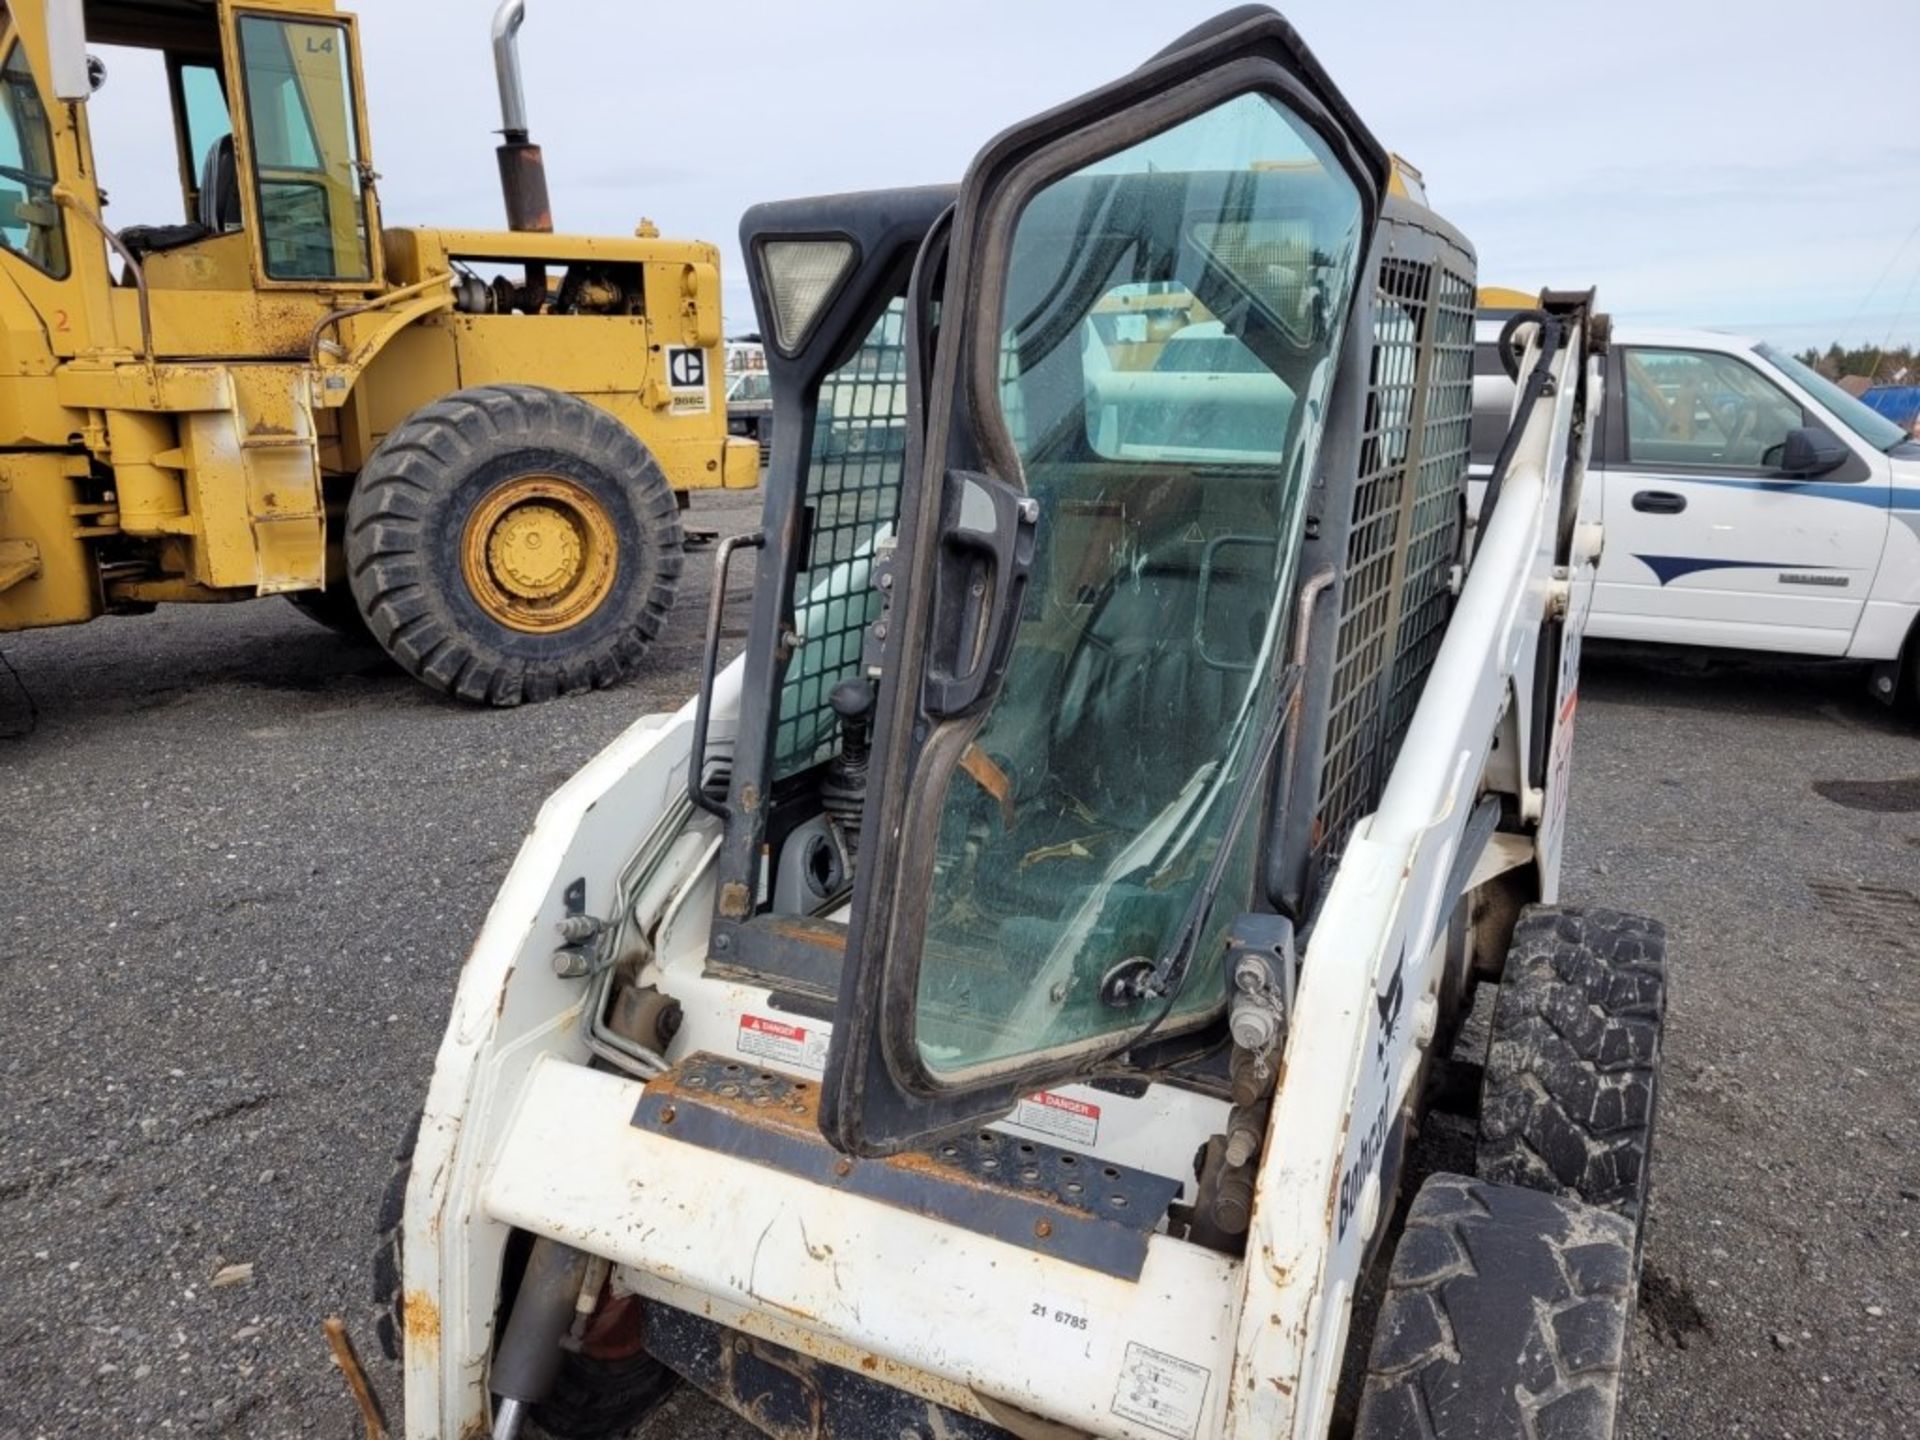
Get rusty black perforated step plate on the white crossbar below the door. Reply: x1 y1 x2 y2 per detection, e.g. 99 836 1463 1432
634 1054 1181 1281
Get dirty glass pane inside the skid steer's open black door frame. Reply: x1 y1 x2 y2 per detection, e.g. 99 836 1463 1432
916 94 1363 1083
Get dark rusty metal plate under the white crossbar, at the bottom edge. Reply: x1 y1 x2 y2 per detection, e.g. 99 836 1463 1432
647 1306 1010 1440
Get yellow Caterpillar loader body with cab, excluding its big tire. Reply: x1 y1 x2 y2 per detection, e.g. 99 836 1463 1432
0 0 758 632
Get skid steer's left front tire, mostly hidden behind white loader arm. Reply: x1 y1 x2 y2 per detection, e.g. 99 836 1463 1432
372 1116 680 1440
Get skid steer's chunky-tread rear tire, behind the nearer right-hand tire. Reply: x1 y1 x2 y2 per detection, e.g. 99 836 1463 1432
1475 906 1667 1225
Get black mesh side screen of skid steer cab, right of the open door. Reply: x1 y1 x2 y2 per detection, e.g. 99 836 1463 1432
1315 250 1473 854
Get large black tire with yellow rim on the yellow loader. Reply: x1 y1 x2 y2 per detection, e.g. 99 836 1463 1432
346 386 682 705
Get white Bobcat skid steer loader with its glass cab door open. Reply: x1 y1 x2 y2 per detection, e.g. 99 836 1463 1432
378 8 1665 1440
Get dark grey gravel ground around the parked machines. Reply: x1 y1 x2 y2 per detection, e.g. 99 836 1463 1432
0 497 1920 1440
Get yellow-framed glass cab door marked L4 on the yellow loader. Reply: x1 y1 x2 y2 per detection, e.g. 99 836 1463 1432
238 15 372 280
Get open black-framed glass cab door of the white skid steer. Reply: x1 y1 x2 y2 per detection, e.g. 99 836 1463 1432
822 12 1384 1154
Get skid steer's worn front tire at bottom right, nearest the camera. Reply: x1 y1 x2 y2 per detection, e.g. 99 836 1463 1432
1354 1175 1634 1440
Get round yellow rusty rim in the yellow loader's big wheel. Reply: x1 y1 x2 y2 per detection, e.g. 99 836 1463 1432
461 474 620 636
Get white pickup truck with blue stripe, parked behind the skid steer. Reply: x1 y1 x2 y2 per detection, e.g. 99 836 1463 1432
1469 309 1920 710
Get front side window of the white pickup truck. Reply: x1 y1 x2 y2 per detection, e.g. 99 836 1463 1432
1622 346 1807 470
